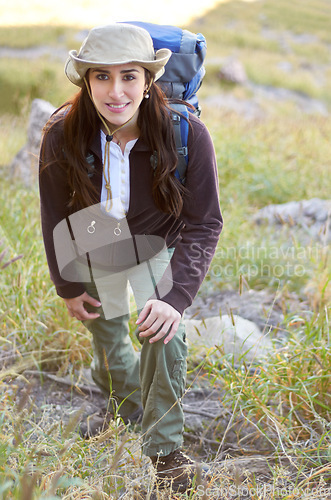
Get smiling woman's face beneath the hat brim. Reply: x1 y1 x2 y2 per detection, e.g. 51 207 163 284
89 63 147 129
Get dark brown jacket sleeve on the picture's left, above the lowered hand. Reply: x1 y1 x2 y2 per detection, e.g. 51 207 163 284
39 124 85 298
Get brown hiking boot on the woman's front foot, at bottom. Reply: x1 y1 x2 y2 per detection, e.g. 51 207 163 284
151 449 208 493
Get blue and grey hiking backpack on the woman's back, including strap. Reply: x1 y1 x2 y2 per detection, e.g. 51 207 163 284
129 21 207 184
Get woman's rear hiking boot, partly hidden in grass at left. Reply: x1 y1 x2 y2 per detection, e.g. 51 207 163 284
79 406 143 439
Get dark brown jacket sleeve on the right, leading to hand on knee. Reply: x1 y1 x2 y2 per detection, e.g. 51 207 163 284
161 117 223 314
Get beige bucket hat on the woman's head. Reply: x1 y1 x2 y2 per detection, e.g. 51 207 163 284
65 23 171 87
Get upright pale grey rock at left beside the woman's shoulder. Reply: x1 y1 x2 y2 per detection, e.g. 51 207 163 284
10 99 55 186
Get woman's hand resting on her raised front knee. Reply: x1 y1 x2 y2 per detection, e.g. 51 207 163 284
136 300 181 344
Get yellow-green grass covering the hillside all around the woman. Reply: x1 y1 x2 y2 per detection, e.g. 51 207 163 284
0 0 331 500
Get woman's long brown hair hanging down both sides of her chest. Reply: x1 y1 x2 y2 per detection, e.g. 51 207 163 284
44 70 185 217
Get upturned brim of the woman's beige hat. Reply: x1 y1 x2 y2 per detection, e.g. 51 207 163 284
64 49 172 87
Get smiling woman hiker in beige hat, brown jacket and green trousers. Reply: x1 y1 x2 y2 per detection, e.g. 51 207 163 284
40 23 222 491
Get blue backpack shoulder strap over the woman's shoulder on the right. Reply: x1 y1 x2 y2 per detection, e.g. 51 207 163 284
171 103 189 184
